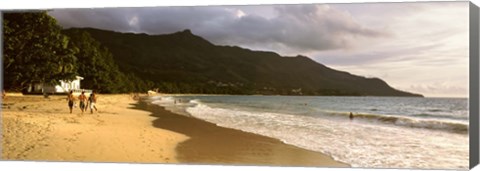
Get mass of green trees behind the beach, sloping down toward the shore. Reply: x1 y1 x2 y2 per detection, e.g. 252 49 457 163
3 12 153 93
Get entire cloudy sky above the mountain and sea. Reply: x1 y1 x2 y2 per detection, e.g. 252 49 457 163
49 2 469 97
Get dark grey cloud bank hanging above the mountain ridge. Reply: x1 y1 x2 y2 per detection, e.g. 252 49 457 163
50 5 386 53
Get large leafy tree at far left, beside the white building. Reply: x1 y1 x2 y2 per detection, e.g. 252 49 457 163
3 12 78 90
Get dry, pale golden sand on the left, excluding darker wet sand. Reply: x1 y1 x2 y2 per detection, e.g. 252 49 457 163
2 95 188 163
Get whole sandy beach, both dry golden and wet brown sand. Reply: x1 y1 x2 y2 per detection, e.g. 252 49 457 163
2 95 349 167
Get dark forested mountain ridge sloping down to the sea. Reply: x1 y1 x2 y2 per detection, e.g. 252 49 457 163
66 28 423 97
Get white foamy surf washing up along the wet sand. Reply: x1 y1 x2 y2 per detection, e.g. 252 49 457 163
148 97 469 169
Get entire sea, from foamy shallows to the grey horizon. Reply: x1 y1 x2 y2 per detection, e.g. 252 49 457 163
150 96 469 169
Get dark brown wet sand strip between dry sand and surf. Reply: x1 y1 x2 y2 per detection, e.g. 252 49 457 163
134 99 350 167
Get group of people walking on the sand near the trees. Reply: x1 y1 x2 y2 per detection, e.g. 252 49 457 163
67 91 97 114
